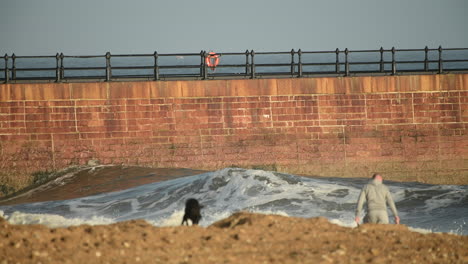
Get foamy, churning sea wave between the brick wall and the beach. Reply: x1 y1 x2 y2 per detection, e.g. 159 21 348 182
0 168 468 235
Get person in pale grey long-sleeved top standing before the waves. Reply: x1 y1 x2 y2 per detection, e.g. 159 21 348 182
354 173 400 225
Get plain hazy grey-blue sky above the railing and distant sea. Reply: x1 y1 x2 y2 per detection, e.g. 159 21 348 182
0 0 468 56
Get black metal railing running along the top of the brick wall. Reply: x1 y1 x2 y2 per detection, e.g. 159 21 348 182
0 47 468 83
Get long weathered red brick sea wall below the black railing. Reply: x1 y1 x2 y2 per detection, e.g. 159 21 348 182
0 74 468 184
